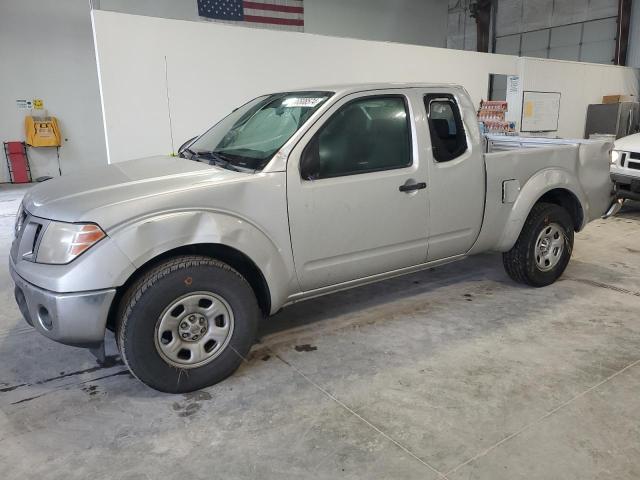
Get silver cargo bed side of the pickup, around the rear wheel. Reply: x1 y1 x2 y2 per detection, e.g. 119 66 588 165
471 135 613 253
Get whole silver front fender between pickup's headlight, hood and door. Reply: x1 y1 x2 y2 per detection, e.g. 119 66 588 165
109 172 299 312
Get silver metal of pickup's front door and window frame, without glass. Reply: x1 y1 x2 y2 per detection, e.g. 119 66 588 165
287 89 428 293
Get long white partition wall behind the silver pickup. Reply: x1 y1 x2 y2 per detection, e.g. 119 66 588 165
94 11 638 162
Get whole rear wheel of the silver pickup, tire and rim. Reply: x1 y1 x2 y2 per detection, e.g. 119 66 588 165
502 203 574 287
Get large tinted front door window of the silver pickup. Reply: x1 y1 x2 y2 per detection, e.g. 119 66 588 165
301 96 411 180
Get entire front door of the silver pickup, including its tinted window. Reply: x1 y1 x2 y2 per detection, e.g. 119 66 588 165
287 90 428 291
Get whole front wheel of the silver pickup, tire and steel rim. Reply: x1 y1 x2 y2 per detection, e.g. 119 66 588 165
116 256 260 393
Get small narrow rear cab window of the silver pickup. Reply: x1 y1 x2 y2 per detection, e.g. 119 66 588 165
424 95 467 162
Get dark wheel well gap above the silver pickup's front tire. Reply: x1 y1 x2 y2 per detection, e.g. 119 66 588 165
107 243 271 331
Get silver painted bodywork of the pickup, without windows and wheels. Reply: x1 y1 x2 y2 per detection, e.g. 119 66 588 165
10 80 611 344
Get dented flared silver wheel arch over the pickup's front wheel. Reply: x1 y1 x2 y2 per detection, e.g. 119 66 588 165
109 210 297 309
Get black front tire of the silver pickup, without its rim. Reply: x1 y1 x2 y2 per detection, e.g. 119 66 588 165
116 256 261 393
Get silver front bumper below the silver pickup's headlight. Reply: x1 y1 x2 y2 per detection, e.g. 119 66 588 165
9 262 116 348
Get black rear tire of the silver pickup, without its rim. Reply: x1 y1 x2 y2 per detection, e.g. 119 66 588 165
502 203 574 287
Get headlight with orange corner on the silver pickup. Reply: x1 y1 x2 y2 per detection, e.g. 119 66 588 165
36 221 106 264
